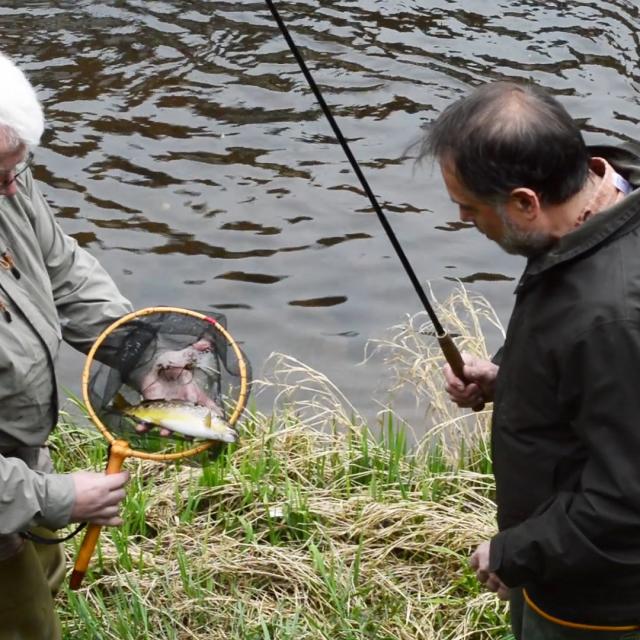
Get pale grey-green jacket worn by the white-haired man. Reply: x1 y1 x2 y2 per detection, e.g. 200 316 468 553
0 172 131 534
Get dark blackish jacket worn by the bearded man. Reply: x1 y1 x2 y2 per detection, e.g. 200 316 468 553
490 148 640 625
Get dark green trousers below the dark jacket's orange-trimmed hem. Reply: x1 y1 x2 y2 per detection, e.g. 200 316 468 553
509 589 640 640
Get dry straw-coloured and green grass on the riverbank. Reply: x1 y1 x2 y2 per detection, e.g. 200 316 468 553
54 290 507 640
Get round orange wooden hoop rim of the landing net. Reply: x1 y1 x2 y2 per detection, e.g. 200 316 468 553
82 307 249 462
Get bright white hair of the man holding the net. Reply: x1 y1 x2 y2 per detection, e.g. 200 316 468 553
0 53 44 148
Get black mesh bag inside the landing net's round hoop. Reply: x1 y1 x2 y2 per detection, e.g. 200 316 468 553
88 310 251 453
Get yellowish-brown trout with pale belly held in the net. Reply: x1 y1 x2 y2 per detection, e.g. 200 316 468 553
114 400 238 442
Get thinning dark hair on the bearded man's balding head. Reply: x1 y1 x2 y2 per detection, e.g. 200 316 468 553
420 82 589 204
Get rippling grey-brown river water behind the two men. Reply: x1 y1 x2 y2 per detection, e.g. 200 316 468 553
0 0 640 429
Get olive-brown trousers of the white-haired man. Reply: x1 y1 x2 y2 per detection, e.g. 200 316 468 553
0 529 65 640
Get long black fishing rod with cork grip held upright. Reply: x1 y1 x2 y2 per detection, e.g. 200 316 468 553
265 0 484 411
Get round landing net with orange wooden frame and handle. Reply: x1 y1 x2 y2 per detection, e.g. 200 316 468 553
70 307 251 589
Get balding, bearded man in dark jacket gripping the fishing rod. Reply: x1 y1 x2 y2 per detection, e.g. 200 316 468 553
421 82 640 640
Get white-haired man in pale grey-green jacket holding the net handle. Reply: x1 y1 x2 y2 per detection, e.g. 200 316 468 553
0 54 131 640
